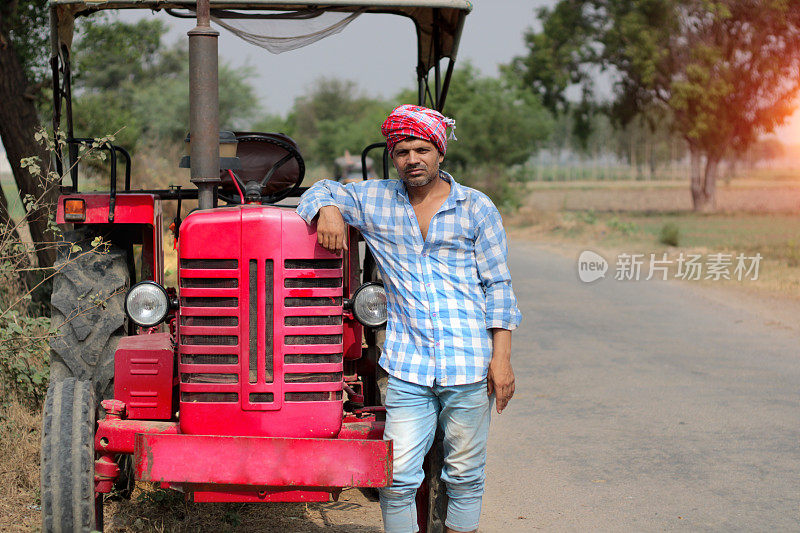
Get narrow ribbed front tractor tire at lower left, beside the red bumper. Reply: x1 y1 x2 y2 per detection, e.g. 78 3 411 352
41 378 103 533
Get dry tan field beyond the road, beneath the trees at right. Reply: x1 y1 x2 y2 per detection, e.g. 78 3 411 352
506 181 800 298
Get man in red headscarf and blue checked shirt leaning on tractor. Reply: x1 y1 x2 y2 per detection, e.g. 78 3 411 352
297 105 521 533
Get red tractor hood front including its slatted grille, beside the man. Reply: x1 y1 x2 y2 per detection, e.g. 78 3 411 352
176 206 346 438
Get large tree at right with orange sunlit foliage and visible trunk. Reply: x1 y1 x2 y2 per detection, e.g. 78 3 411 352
511 0 800 210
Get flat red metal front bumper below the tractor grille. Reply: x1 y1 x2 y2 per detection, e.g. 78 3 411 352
95 409 392 501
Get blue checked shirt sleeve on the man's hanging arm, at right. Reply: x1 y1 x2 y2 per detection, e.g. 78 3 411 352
475 199 522 330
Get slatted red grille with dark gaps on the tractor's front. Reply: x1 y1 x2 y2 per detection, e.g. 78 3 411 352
179 254 343 404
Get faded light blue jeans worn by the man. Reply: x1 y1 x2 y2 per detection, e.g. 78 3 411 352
380 376 493 533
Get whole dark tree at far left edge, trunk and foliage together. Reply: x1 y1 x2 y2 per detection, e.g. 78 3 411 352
0 0 57 267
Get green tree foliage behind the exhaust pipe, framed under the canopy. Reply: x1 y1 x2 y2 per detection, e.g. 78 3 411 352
73 17 257 150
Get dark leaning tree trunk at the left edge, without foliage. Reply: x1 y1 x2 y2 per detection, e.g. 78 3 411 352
0 35 58 267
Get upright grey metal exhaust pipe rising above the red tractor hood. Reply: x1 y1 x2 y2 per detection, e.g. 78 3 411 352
188 0 220 209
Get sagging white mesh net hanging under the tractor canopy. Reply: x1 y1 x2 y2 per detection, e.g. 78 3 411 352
212 10 363 54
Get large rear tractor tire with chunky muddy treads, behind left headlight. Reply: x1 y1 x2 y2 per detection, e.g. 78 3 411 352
50 228 131 399
